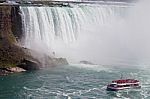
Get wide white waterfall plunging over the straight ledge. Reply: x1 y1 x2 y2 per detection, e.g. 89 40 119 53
20 4 131 61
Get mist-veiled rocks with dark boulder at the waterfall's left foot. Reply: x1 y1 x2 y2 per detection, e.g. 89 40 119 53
19 48 68 70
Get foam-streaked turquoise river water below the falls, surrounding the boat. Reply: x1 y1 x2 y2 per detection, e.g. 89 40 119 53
0 64 150 99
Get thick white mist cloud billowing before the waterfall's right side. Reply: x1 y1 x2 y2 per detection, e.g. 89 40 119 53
51 1 150 64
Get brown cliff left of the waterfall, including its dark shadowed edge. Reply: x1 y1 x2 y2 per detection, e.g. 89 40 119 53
0 6 40 69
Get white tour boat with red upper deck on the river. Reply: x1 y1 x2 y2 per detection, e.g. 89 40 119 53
107 79 141 91
